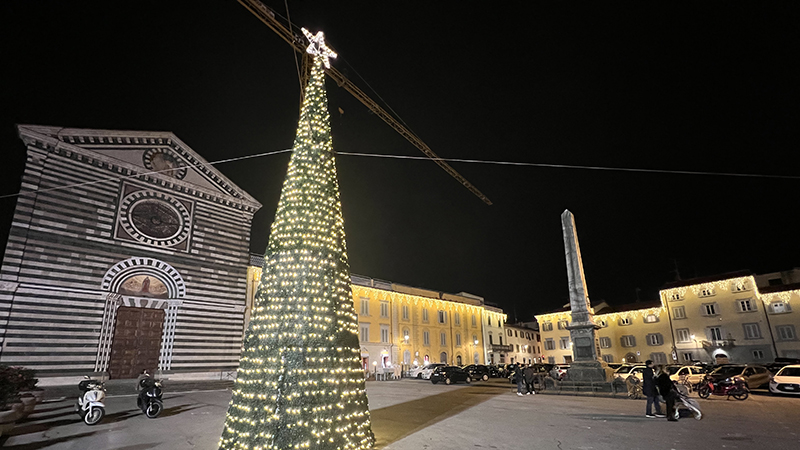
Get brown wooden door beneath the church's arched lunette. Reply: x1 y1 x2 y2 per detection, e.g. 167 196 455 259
108 306 164 379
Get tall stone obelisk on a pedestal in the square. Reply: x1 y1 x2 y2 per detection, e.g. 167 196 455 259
561 209 612 381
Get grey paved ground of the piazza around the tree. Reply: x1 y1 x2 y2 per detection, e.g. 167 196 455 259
0 380 800 450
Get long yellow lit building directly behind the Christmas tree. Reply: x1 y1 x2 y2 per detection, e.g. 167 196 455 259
245 255 506 372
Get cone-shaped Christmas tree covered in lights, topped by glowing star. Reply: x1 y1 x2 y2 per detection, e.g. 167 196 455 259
220 30 374 450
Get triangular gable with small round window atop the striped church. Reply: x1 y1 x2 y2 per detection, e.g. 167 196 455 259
18 125 261 210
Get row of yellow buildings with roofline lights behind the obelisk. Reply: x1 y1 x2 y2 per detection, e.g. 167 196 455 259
536 271 800 364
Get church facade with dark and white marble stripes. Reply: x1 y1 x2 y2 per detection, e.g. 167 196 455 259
0 125 261 382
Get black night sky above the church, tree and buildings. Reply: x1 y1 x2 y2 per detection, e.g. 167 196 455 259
0 0 800 320
